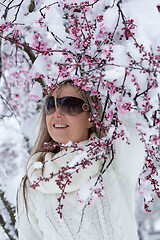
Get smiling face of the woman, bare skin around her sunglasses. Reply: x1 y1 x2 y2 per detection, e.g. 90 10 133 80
46 85 93 144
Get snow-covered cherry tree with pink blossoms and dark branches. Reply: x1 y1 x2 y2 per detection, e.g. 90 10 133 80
0 0 160 239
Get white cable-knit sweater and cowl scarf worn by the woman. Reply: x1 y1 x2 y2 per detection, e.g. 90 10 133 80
18 117 144 240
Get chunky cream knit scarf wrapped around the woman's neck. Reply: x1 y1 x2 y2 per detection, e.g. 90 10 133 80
27 140 102 194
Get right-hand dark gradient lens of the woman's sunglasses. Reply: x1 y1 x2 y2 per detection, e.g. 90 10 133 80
61 97 84 116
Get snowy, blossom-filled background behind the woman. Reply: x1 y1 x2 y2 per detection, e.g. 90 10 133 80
0 0 160 240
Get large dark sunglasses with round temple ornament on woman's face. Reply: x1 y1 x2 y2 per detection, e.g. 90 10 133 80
45 96 89 116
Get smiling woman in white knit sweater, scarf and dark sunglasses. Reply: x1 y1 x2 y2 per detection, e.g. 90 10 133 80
18 80 144 240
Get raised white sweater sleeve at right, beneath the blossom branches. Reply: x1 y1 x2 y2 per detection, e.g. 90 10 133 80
114 113 145 182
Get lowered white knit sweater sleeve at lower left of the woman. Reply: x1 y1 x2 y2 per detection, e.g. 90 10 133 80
17 177 43 240
